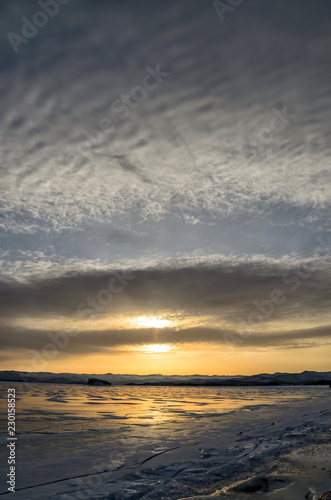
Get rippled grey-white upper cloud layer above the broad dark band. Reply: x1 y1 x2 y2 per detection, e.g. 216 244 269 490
0 0 331 282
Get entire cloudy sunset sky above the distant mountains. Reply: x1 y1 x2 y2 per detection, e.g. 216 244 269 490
0 0 331 375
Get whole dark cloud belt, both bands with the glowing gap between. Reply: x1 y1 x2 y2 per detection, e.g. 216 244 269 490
0 261 331 364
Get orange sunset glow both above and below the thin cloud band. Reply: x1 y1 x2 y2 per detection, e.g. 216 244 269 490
2 312 331 375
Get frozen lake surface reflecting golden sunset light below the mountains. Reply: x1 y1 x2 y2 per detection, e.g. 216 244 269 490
0 382 331 500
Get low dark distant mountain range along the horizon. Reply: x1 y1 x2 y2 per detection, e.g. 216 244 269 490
0 371 331 387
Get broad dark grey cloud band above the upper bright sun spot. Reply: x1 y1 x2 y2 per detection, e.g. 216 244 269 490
0 261 331 330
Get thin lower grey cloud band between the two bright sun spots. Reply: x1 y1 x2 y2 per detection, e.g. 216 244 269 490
0 324 331 356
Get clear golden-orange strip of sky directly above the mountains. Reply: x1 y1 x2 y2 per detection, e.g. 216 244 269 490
2 343 331 376
